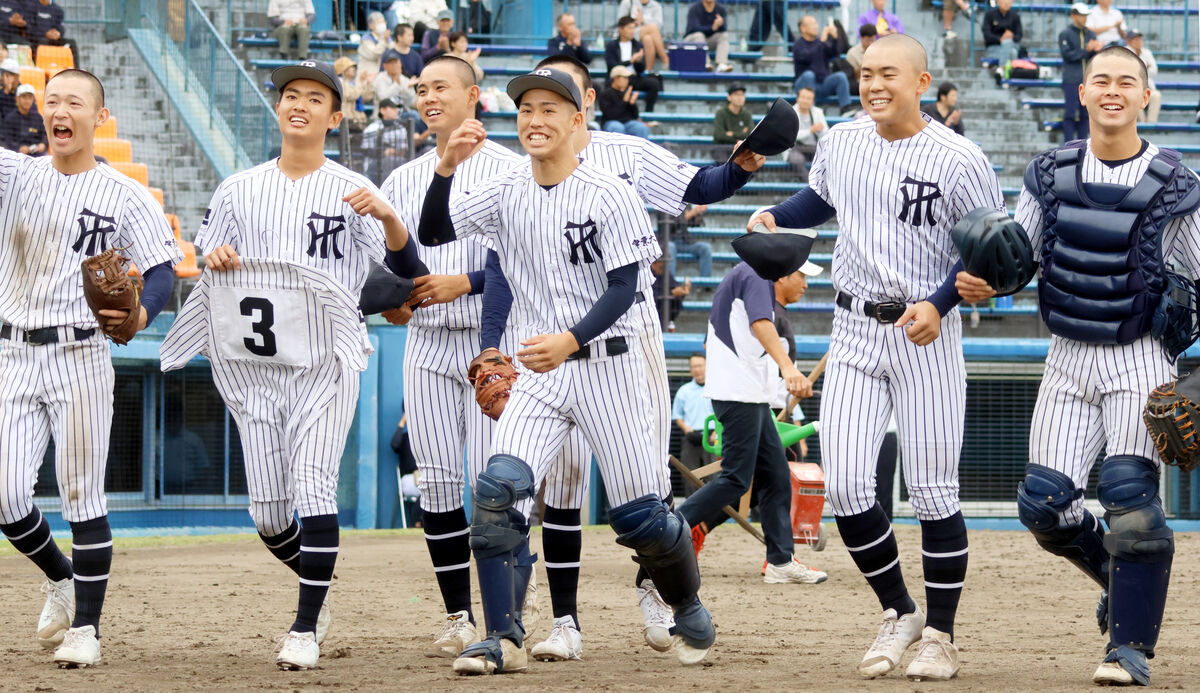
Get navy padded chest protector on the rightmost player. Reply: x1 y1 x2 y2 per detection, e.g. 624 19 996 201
1025 141 1200 344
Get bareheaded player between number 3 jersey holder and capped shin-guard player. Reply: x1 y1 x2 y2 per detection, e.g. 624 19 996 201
382 56 521 657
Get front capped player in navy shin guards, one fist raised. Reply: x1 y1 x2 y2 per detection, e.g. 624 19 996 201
418 68 715 674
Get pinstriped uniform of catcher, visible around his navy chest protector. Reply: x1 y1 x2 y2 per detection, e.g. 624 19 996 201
1015 143 1200 526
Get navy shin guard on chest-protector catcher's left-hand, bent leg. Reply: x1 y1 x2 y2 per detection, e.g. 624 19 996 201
1016 464 1109 589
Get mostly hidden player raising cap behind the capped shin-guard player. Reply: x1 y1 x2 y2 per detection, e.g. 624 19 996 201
472 55 766 661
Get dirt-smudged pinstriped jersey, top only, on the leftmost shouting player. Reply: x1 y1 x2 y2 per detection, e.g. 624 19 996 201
0 156 184 330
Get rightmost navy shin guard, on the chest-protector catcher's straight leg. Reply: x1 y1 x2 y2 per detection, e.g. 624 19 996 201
1096 456 1175 658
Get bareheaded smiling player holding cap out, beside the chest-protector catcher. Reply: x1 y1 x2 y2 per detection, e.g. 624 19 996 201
750 35 1003 680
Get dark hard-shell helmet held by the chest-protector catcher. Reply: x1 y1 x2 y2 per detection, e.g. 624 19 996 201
950 207 1037 296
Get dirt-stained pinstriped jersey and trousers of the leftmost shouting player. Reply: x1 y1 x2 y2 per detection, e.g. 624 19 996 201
0 157 182 524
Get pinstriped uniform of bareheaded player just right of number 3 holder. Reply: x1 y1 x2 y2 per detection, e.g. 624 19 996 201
382 140 521 512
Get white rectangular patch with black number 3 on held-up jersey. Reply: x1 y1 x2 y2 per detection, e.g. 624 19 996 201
210 287 311 368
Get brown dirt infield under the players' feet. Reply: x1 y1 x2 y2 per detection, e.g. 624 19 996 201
0 525 1200 692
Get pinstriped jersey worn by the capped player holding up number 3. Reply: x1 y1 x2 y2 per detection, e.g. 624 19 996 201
196 158 386 296
